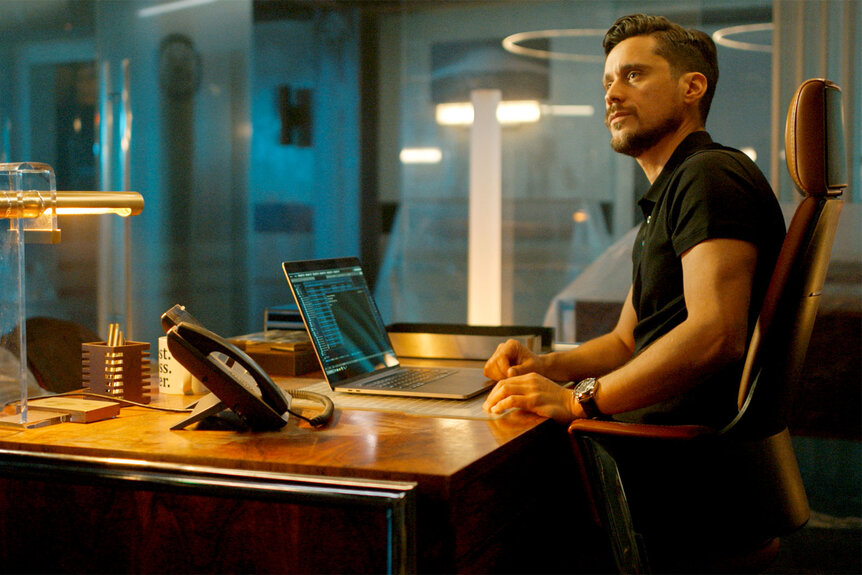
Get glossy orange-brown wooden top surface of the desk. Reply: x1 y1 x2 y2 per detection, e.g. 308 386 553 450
0 382 543 491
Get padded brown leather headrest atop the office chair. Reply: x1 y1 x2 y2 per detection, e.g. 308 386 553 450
784 78 847 196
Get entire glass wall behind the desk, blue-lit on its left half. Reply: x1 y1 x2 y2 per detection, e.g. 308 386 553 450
0 0 862 352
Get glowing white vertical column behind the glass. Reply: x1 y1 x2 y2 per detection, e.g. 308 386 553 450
467 90 503 325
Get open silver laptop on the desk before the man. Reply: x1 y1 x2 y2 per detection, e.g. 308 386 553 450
282 258 494 399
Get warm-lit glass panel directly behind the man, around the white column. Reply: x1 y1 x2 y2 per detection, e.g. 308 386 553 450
376 0 859 341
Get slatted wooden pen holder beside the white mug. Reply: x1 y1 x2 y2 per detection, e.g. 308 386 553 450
81 341 151 403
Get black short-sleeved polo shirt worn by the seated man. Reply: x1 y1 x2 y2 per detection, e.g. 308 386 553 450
632 132 785 426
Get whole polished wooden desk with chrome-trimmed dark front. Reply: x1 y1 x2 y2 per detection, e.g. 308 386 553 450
0 380 592 573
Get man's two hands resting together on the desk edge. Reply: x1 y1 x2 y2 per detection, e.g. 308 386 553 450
482 340 582 424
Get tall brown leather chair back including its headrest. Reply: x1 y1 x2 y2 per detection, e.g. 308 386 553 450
725 79 847 437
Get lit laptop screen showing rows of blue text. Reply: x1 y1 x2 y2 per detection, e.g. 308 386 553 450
283 258 398 385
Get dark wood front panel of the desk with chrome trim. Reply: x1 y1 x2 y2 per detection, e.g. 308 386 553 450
0 450 416 573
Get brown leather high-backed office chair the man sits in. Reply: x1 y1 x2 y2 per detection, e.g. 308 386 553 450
569 79 847 573
